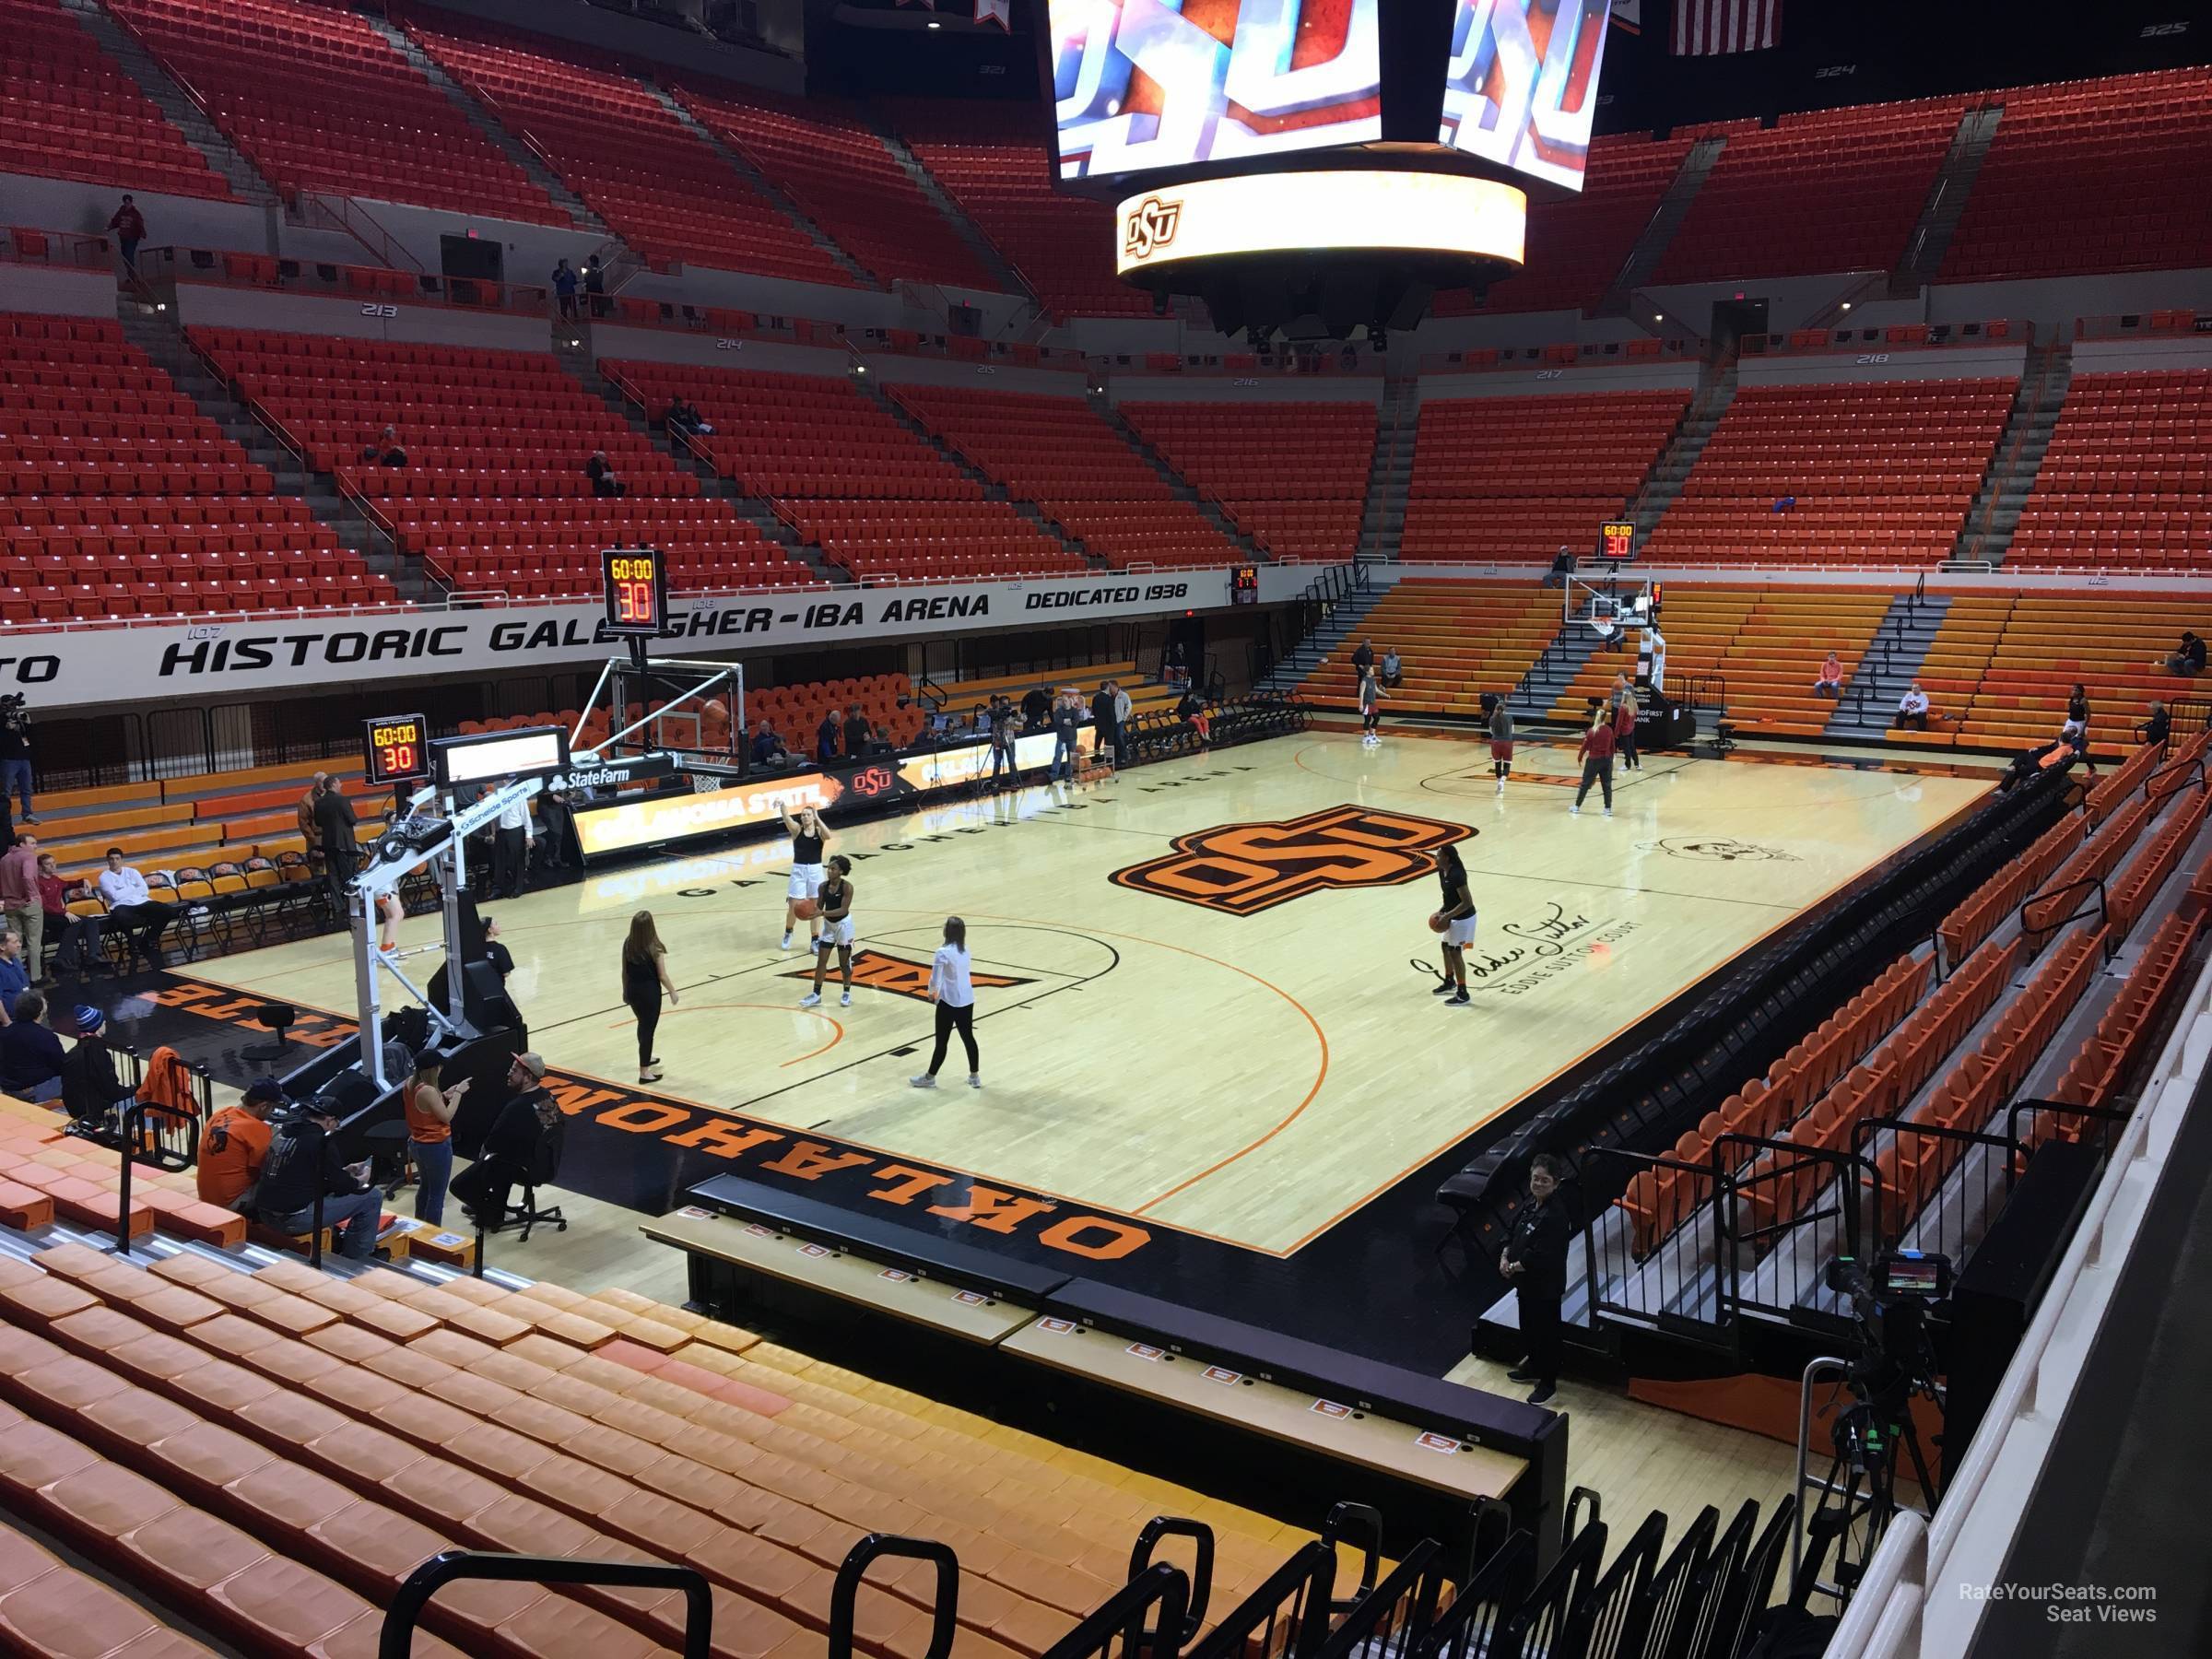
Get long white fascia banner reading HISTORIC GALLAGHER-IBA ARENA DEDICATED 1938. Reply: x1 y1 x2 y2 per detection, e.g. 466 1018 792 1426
13 564 1291 712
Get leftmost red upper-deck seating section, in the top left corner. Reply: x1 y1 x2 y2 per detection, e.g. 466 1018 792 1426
0 0 230 201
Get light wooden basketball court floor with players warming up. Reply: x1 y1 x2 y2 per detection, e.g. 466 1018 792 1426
175 732 1993 1259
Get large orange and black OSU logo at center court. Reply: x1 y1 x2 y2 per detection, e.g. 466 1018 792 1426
1112 806 1466 916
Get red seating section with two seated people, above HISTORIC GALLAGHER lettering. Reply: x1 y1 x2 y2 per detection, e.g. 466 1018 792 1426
193 327 814 597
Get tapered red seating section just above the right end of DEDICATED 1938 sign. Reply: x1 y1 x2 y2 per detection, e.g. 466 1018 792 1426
1119 398 1376 559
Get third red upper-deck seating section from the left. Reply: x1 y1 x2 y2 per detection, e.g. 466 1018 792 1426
403 11 853 288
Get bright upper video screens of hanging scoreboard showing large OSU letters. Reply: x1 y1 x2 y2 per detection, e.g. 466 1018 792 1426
1046 0 1610 190
